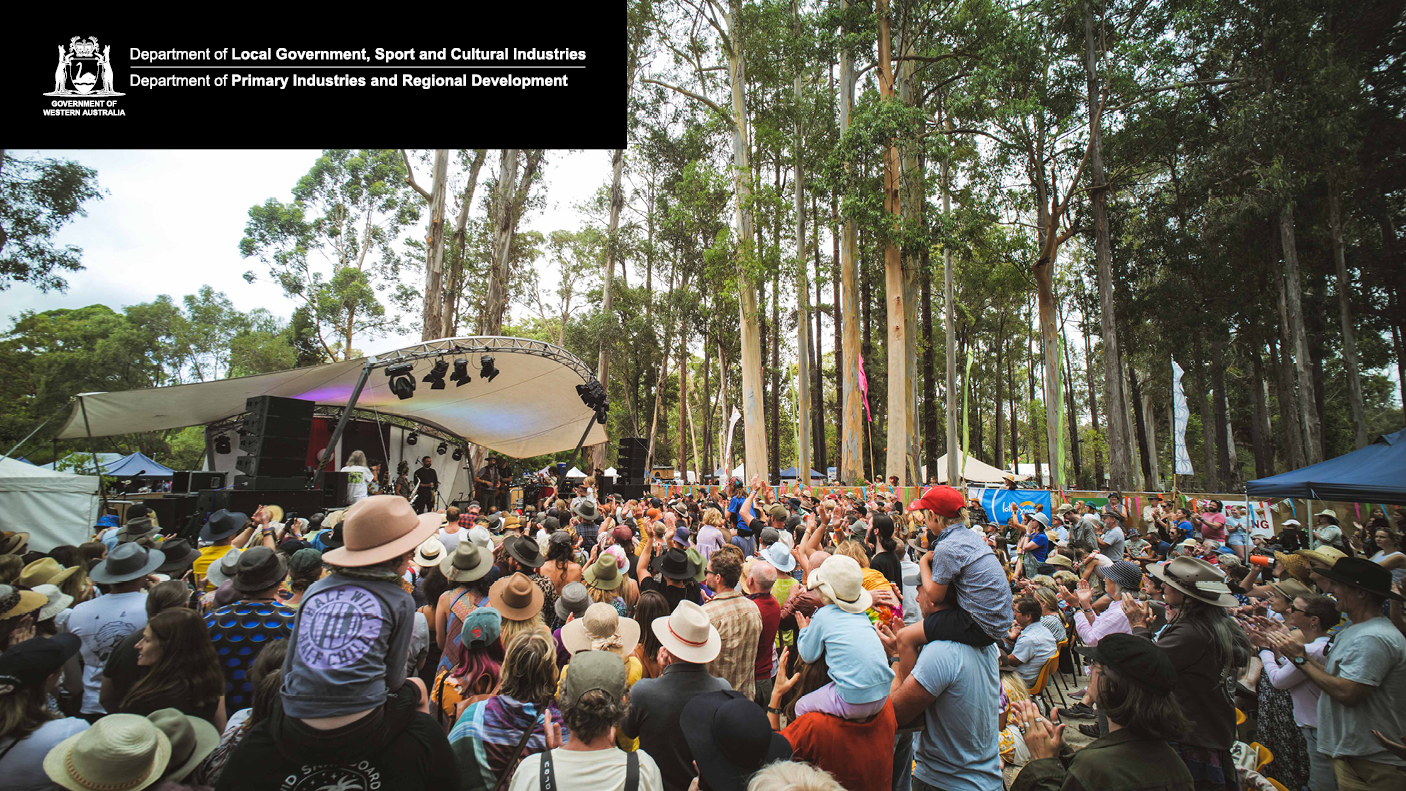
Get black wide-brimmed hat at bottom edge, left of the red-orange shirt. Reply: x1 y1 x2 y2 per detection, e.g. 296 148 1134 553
683 690 792 791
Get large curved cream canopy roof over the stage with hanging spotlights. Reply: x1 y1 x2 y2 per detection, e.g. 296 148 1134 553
58 337 606 458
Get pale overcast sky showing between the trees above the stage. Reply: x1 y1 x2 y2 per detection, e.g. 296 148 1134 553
0 149 610 354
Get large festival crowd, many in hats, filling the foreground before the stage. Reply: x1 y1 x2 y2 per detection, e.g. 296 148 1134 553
0 469 1406 791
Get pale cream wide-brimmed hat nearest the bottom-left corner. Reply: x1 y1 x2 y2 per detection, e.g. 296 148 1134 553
44 714 172 791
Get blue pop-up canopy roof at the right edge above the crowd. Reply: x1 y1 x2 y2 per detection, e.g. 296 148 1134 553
1246 429 1406 504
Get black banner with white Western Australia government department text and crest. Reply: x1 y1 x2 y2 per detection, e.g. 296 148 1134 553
0 12 626 149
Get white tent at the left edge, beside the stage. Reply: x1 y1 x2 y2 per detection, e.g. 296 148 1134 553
0 458 100 552
